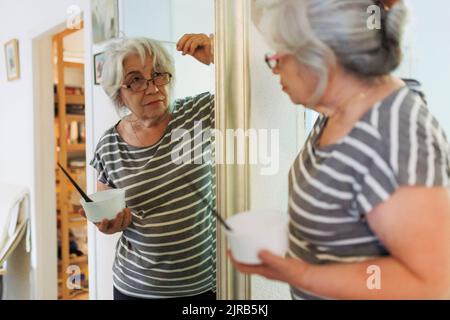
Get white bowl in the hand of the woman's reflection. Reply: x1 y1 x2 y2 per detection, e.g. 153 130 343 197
80 189 125 222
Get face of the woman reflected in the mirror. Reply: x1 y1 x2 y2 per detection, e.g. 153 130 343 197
120 54 170 124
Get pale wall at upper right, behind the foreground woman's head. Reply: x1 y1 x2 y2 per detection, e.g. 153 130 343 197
400 0 450 137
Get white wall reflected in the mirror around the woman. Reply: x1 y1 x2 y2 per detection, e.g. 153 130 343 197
88 0 214 299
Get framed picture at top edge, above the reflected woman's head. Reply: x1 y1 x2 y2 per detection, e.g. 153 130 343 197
91 0 119 44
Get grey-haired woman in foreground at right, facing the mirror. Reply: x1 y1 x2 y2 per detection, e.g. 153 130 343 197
234 0 450 299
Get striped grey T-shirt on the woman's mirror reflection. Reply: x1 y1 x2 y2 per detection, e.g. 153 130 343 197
91 93 216 298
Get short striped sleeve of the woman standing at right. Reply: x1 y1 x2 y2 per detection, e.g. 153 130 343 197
355 93 450 214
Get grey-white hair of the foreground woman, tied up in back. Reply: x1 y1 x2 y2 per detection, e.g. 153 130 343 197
253 0 407 104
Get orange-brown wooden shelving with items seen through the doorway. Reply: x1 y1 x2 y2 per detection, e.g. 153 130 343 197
53 24 89 299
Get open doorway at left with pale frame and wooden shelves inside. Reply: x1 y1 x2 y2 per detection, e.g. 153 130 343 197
32 22 88 300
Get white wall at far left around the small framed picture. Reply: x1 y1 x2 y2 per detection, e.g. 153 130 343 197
0 0 89 299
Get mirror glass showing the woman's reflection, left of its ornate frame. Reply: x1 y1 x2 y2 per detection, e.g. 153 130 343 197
91 0 216 299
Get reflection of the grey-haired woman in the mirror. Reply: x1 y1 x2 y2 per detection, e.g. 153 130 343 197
84 34 216 300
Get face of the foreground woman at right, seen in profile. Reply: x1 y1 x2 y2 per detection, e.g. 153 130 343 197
272 54 318 105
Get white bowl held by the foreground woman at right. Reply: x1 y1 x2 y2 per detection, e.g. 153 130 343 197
227 211 288 264
